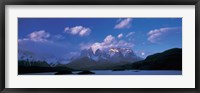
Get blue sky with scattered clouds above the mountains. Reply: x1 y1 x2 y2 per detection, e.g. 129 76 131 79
18 18 182 62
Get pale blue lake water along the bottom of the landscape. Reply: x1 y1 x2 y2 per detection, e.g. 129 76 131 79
21 70 182 75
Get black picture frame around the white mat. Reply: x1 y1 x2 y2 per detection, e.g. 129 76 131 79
0 0 200 93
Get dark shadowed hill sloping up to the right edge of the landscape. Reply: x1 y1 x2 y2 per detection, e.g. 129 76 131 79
132 48 182 70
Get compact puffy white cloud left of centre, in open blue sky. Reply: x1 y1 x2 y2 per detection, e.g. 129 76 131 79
64 26 91 36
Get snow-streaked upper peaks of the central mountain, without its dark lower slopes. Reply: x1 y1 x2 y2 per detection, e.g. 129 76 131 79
81 48 141 62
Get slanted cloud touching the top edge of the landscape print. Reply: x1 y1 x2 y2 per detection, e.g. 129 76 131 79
114 18 132 29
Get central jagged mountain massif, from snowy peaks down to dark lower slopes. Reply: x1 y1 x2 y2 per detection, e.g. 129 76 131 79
67 48 143 70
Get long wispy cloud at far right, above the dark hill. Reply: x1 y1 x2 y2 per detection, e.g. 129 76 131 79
147 27 180 43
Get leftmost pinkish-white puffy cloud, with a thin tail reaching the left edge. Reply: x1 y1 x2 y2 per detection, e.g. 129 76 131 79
18 30 50 42
